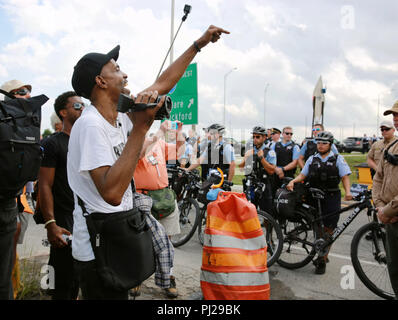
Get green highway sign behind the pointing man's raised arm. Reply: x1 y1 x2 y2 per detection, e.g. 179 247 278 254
169 63 198 124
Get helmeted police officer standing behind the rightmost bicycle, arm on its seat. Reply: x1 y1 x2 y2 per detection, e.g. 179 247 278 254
287 131 352 274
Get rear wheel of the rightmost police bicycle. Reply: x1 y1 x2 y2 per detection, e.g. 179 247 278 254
277 215 316 269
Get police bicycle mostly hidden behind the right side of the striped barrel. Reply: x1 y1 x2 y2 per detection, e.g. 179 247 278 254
242 172 283 267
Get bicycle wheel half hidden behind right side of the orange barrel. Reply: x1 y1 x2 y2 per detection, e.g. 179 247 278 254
257 210 283 267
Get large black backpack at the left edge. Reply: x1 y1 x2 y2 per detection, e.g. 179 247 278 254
0 90 48 200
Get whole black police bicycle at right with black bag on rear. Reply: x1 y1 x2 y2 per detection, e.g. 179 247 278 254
275 184 395 299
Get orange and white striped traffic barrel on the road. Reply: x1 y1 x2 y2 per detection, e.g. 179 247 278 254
200 192 270 300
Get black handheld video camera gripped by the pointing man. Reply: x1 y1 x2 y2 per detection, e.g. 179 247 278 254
117 93 173 120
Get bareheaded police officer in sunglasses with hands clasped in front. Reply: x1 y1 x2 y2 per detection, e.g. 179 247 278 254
271 127 300 194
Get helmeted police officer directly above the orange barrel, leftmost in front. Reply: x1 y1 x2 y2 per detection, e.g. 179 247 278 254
187 123 235 182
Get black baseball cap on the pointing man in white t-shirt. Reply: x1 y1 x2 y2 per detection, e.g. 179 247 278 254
72 45 120 99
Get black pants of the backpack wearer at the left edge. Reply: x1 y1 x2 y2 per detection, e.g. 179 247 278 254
0 199 18 300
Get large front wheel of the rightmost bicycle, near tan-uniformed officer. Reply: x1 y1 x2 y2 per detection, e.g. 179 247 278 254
351 222 395 299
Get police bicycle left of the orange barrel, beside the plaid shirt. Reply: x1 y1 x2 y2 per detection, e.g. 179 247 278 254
167 167 201 247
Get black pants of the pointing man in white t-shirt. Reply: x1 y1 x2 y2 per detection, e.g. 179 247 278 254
74 260 128 300
